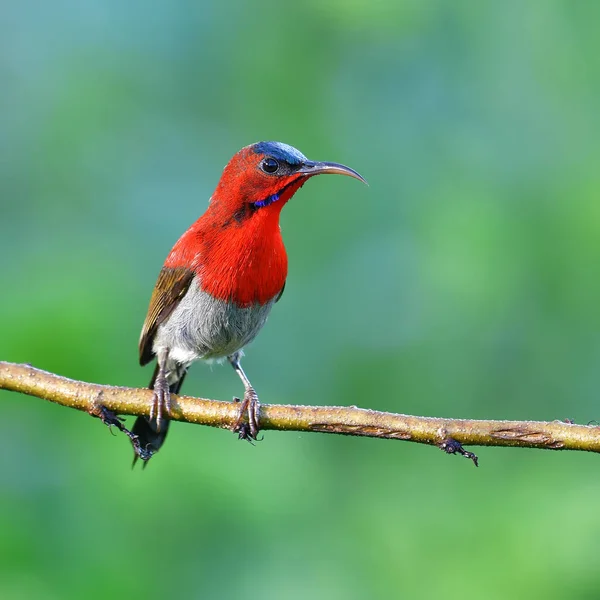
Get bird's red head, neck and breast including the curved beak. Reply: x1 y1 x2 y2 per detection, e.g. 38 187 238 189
165 142 364 307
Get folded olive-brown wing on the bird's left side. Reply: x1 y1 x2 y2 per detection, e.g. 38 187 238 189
140 267 194 366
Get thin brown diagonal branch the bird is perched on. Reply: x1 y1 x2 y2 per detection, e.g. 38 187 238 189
0 361 600 464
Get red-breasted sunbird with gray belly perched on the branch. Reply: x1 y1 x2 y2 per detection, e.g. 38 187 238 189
132 141 367 467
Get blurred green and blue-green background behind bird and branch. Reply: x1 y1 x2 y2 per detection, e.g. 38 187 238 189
0 0 600 600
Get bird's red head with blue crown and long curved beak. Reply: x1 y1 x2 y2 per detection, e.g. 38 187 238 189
211 142 367 223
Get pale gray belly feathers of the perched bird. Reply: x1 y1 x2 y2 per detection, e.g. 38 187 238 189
153 278 275 366
